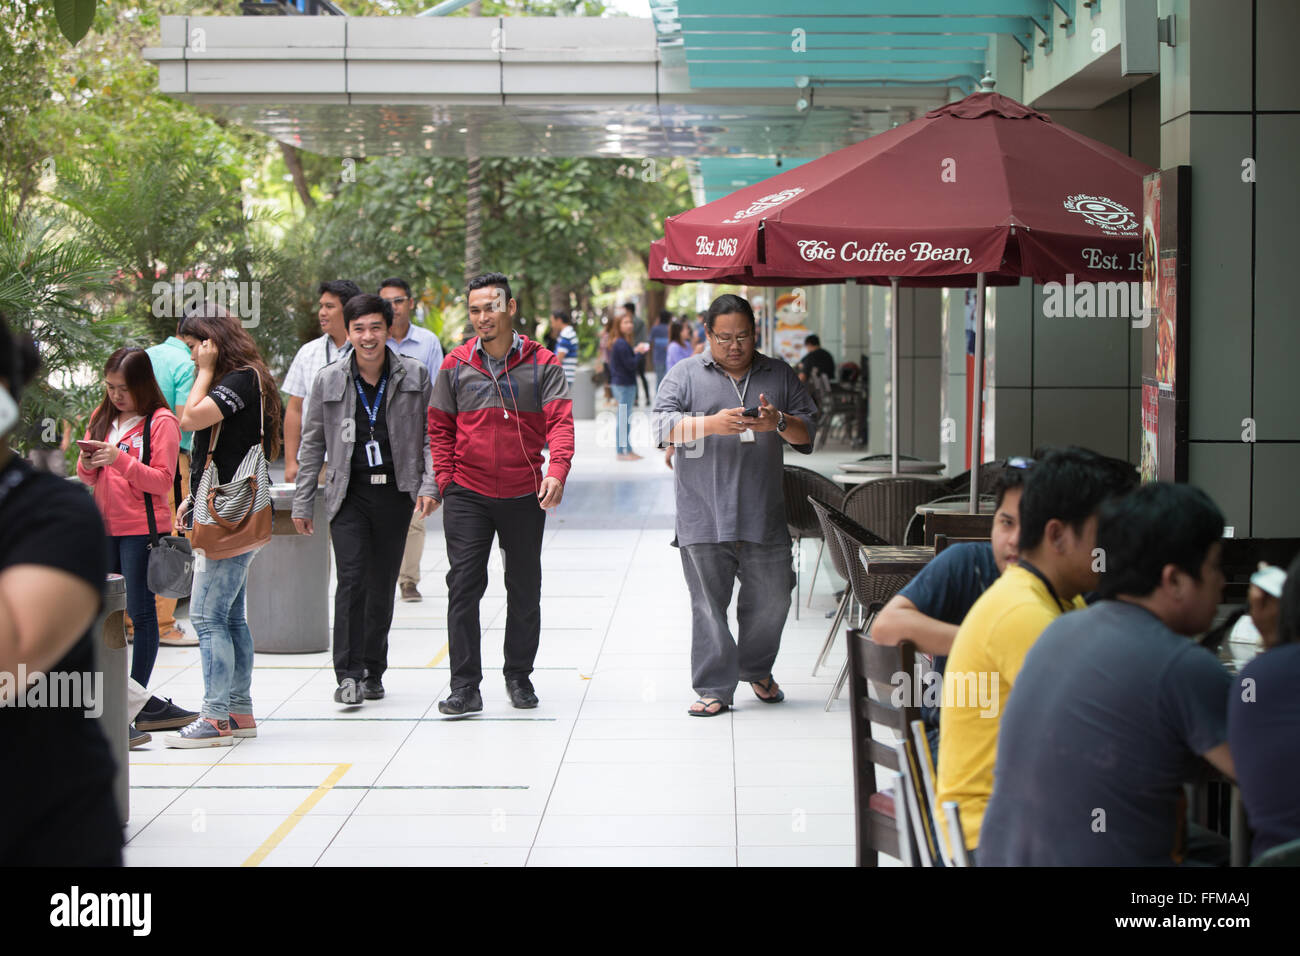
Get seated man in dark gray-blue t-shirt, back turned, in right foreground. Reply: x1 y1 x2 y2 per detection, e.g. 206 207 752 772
979 484 1234 866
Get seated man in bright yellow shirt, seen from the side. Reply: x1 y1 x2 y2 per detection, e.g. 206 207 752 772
939 447 1138 852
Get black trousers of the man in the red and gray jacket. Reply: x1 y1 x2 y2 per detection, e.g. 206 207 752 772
442 483 546 691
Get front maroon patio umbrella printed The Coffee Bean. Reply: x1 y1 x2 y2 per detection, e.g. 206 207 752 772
664 91 1154 509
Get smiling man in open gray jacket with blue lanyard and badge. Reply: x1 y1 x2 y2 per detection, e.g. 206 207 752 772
294 295 441 706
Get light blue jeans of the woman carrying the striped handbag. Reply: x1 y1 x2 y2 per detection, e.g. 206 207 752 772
190 551 256 721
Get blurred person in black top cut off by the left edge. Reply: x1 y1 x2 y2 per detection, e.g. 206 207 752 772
0 315 122 866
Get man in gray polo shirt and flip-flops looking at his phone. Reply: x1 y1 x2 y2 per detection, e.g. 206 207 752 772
654 295 816 717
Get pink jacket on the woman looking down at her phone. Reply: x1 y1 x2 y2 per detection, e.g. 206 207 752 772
77 408 181 537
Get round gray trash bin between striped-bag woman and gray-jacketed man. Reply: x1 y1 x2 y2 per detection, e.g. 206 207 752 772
247 484 330 654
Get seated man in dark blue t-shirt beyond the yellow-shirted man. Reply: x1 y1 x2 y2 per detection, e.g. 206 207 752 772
871 458 1034 766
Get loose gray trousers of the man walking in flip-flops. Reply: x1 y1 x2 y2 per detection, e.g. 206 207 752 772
680 541 794 704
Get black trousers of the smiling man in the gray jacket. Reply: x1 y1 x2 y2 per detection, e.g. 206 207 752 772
329 475 415 682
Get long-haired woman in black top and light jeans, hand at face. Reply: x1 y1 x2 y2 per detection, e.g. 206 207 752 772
164 306 281 748
